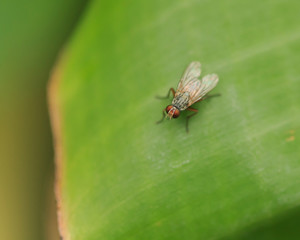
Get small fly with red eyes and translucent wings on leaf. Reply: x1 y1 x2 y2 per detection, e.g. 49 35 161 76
157 62 220 132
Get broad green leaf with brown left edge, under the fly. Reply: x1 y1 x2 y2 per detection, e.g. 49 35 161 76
52 0 300 240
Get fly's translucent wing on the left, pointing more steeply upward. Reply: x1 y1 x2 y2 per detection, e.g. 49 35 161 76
177 62 201 92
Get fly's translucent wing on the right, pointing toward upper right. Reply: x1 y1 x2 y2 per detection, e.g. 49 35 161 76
189 74 219 105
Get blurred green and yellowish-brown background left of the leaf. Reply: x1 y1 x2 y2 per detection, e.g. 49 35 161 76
0 0 87 240
